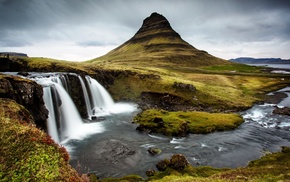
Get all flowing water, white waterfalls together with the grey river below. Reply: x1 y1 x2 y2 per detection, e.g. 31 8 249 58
3 73 290 177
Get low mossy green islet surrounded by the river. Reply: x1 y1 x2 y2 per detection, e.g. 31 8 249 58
134 109 243 136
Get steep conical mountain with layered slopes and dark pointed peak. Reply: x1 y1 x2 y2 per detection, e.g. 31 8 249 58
92 13 229 67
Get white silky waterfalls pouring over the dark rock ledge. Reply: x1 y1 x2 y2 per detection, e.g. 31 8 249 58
33 74 136 143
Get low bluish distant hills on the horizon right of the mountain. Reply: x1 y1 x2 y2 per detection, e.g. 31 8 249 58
230 57 290 64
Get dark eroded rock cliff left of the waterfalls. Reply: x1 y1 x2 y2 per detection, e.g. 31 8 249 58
0 74 48 130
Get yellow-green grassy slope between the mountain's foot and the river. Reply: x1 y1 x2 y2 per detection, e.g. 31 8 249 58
109 66 290 111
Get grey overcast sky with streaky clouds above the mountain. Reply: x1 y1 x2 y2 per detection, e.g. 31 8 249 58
0 0 290 61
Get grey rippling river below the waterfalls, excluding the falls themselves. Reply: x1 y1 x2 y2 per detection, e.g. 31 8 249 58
64 87 290 177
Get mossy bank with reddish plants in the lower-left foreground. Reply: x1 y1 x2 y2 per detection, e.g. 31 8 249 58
0 99 84 181
